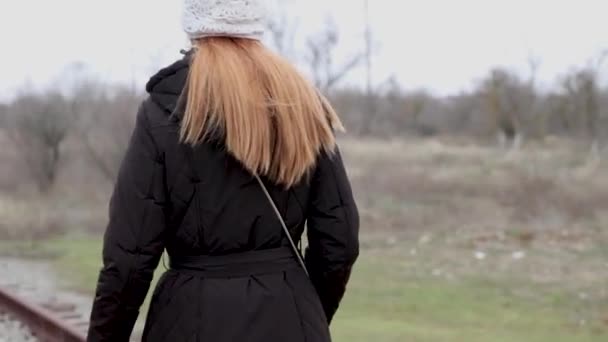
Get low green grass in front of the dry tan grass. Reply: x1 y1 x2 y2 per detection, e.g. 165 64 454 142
0 237 608 342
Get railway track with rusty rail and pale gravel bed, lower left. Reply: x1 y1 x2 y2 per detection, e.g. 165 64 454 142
0 256 144 342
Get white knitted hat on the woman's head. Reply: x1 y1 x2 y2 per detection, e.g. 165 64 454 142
182 0 266 40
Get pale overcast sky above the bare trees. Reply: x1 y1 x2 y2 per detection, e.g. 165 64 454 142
0 0 608 99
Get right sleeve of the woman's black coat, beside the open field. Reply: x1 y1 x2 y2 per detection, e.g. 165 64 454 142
306 150 359 322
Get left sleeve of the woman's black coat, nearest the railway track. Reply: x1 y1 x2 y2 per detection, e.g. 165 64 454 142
87 105 166 342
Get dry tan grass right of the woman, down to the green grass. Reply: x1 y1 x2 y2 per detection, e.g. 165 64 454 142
342 136 608 307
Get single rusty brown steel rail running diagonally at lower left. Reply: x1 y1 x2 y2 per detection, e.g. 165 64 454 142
0 288 86 342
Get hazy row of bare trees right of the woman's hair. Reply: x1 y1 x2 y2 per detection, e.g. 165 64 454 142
330 56 608 149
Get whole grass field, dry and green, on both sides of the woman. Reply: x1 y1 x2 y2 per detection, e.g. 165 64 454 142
0 138 608 342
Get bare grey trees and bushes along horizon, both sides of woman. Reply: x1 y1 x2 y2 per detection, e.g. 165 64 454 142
0 8 608 192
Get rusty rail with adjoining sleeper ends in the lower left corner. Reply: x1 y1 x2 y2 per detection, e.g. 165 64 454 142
0 285 88 342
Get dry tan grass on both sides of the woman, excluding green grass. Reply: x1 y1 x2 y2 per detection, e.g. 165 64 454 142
0 134 608 283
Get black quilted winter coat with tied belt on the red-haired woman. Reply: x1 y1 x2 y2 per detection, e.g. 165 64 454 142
88 56 359 342
